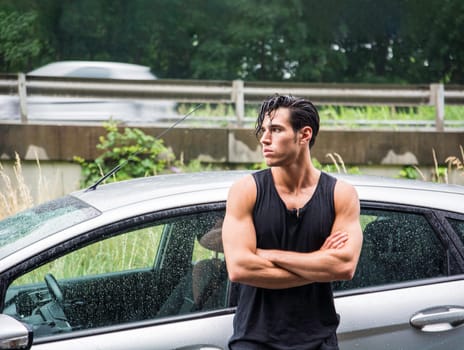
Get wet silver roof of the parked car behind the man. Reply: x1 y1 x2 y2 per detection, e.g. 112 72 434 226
72 170 464 213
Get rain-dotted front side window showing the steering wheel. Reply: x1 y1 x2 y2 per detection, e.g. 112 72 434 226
3 211 228 338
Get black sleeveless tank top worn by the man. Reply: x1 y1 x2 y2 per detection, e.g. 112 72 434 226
229 169 339 350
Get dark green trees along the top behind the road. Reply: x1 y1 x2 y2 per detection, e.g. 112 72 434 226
0 0 464 84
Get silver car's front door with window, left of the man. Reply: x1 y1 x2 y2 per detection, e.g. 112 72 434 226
2 203 233 350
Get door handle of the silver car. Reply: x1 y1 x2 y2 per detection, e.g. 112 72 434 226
409 306 464 332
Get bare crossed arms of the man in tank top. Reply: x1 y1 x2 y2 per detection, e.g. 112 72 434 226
222 176 362 289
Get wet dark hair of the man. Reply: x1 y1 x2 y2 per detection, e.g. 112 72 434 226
255 94 319 148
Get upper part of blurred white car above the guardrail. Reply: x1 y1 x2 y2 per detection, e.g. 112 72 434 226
28 61 156 79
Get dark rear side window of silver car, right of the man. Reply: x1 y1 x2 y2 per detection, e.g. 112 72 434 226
334 209 448 290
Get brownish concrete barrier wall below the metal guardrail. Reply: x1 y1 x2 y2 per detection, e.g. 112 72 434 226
0 124 464 166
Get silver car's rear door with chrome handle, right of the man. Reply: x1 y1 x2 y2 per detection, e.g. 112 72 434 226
334 203 464 350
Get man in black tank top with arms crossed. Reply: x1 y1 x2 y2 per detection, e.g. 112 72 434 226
222 95 362 350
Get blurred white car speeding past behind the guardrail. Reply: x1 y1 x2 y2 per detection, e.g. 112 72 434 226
0 61 177 124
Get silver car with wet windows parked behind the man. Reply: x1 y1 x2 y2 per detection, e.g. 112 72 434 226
0 171 464 350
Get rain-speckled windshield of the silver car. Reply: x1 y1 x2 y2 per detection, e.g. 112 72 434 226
0 196 100 258
